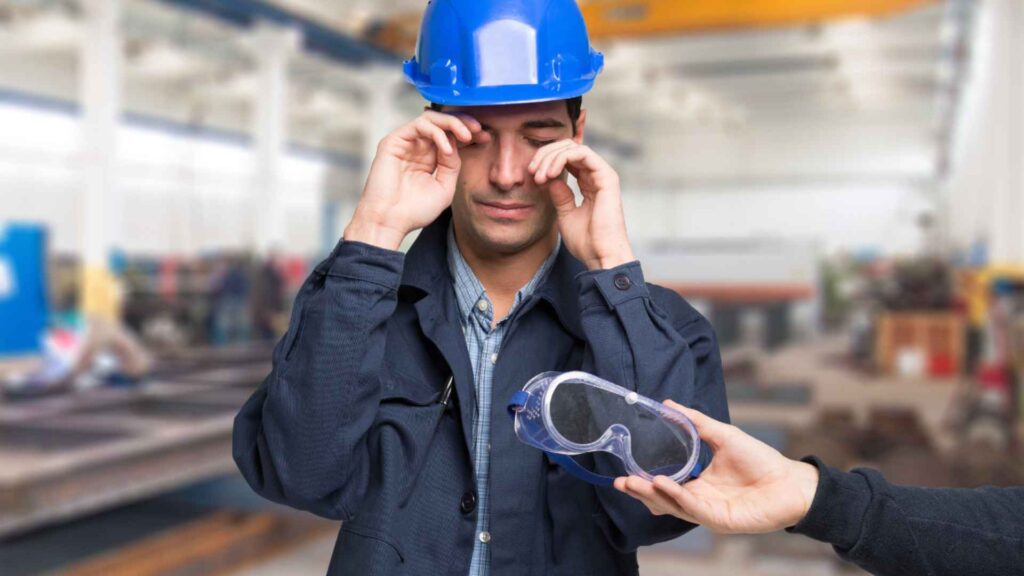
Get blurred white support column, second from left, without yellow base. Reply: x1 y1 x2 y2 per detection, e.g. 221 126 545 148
252 26 301 256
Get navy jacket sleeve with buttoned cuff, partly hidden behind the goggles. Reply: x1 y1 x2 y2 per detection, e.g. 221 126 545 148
577 262 729 551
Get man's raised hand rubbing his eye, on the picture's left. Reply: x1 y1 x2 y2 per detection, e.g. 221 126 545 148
345 111 490 250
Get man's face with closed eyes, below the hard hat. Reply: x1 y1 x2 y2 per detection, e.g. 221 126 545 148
444 101 586 254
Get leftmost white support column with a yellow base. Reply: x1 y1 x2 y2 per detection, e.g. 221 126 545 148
79 0 124 319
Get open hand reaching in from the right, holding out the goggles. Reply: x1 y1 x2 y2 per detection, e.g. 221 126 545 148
615 401 818 534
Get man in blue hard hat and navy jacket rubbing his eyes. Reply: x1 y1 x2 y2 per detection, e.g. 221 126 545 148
234 0 728 576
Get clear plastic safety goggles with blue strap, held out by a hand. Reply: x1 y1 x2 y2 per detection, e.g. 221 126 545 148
508 371 700 486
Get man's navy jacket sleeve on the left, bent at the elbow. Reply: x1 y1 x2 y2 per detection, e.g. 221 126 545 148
232 242 403 520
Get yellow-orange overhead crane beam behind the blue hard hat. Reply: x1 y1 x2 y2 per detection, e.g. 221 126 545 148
365 0 938 56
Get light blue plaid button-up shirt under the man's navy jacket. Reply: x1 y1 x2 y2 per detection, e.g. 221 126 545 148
447 227 561 576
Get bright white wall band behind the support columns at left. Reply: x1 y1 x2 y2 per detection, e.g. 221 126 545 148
0 105 346 256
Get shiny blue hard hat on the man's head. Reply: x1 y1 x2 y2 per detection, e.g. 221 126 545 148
404 0 604 106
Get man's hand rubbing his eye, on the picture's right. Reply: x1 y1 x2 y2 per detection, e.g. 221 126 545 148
529 139 636 270
